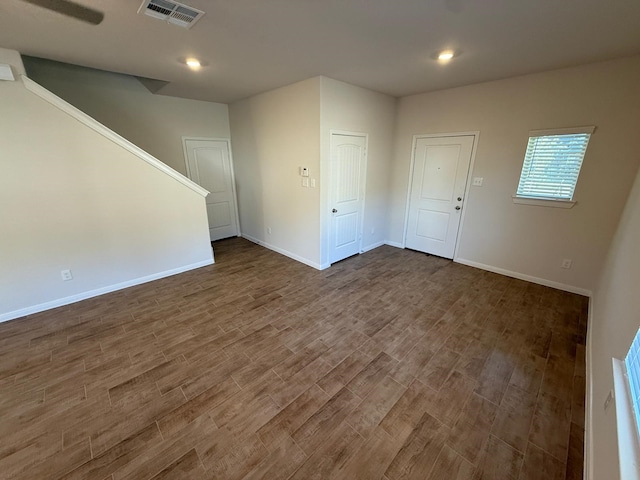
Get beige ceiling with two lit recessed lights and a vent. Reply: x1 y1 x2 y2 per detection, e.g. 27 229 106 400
0 0 640 103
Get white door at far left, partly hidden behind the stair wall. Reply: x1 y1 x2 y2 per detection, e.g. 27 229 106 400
184 139 239 241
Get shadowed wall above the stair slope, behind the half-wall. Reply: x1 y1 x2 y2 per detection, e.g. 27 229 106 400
25 57 229 175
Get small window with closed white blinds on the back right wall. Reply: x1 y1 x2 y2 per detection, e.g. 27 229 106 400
514 127 595 206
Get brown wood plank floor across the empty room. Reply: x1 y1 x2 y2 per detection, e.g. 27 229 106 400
0 239 587 480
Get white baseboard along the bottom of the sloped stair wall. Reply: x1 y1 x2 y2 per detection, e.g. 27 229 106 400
0 258 214 323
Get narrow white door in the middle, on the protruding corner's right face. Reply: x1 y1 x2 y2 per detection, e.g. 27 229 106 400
329 134 366 263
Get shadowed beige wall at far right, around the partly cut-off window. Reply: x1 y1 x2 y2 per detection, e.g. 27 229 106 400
586 164 640 480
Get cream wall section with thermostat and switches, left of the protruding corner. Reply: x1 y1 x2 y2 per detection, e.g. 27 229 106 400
229 77 320 267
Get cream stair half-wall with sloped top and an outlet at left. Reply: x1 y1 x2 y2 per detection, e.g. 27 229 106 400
0 49 212 320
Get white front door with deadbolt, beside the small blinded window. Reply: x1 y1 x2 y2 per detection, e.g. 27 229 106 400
405 135 474 258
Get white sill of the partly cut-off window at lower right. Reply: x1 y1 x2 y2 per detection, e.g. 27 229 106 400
613 358 640 480
